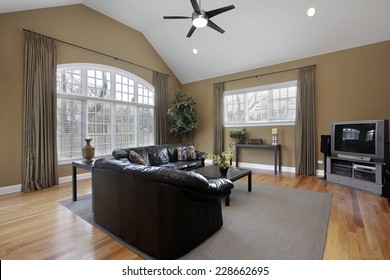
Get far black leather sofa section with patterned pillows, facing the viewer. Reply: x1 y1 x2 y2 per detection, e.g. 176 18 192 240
112 144 205 170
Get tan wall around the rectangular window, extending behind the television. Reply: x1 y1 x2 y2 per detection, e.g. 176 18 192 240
183 41 390 169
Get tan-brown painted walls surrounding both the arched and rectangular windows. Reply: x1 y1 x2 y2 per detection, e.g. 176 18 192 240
0 5 390 187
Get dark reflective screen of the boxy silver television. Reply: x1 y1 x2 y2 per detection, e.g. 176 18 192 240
334 123 376 155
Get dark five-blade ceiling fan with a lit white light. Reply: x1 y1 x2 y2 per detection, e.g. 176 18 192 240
163 0 234 38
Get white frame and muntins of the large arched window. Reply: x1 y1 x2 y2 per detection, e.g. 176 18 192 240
57 63 155 164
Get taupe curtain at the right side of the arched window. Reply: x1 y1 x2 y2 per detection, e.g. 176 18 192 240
153 72 168 145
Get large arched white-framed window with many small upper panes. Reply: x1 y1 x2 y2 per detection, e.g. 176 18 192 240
57 64 154 161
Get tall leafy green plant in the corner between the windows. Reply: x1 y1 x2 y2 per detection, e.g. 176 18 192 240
168 89 199 143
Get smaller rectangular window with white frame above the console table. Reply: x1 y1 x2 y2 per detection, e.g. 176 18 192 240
224 81 297 127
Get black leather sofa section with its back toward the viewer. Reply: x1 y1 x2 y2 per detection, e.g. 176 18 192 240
93 156 233 259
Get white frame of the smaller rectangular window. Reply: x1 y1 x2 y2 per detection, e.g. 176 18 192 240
223 80 298 127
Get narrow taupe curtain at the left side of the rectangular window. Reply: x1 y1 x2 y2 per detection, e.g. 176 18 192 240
213 83 224 155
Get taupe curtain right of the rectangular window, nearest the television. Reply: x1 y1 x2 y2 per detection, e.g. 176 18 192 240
295 66 316 175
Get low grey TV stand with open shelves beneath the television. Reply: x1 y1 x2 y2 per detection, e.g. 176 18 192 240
326 156 386 195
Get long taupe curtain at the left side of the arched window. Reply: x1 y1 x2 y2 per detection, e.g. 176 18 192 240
22 32 58 192
